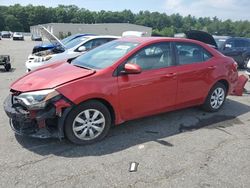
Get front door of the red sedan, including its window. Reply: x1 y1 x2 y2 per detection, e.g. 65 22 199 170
118 42 177 120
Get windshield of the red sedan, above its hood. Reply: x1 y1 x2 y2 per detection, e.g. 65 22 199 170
72 41 139 69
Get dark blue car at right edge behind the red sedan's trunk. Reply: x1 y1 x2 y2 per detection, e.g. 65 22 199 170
216 37 250 68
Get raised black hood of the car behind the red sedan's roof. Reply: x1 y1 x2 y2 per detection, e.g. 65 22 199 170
185 30 218 48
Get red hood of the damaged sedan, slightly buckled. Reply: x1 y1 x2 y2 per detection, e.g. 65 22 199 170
10 62 95 92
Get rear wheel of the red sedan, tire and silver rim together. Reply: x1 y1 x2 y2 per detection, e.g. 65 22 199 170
202 82 226 112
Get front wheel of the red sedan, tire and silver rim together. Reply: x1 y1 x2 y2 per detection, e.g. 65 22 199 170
65 101 111 144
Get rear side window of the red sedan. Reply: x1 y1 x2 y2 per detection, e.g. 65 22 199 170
176 43 212 65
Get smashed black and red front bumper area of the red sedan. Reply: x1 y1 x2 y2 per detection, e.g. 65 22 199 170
4 95 72 139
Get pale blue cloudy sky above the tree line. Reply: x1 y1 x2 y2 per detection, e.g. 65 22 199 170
0 0 250 21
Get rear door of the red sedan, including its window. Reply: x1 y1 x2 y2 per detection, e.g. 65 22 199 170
175 42 216 107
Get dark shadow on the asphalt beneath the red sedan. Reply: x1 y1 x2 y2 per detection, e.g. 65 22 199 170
16 99 250 158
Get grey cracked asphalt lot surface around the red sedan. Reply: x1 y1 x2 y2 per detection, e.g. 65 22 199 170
0 39 250 188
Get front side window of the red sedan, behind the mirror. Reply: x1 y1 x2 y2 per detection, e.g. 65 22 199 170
128 43 174 70
